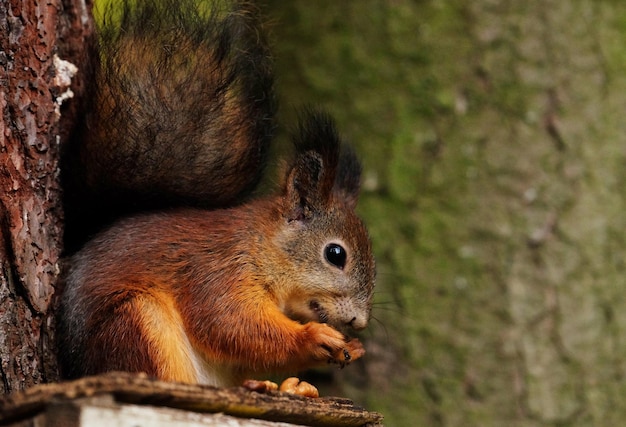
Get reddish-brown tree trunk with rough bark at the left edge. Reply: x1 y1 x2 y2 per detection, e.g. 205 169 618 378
0 0 92 393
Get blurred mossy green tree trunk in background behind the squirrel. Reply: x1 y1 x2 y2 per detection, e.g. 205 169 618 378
268 0 626 426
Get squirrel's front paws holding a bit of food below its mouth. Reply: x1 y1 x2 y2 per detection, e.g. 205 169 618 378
305 322 365 367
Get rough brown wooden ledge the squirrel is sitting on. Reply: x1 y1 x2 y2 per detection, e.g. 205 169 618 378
0 372 383 426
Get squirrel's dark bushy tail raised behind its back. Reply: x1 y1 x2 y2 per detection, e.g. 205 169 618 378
62 0 275 252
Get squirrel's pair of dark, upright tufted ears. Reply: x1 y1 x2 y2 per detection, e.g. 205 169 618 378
285 110 361 220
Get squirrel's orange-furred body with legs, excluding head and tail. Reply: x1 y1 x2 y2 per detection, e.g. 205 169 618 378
59 200 364 385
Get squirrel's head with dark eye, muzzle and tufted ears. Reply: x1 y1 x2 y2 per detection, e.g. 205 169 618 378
275 112 376 330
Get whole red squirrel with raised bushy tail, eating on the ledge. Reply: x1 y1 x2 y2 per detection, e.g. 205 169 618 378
58 0 375 394
